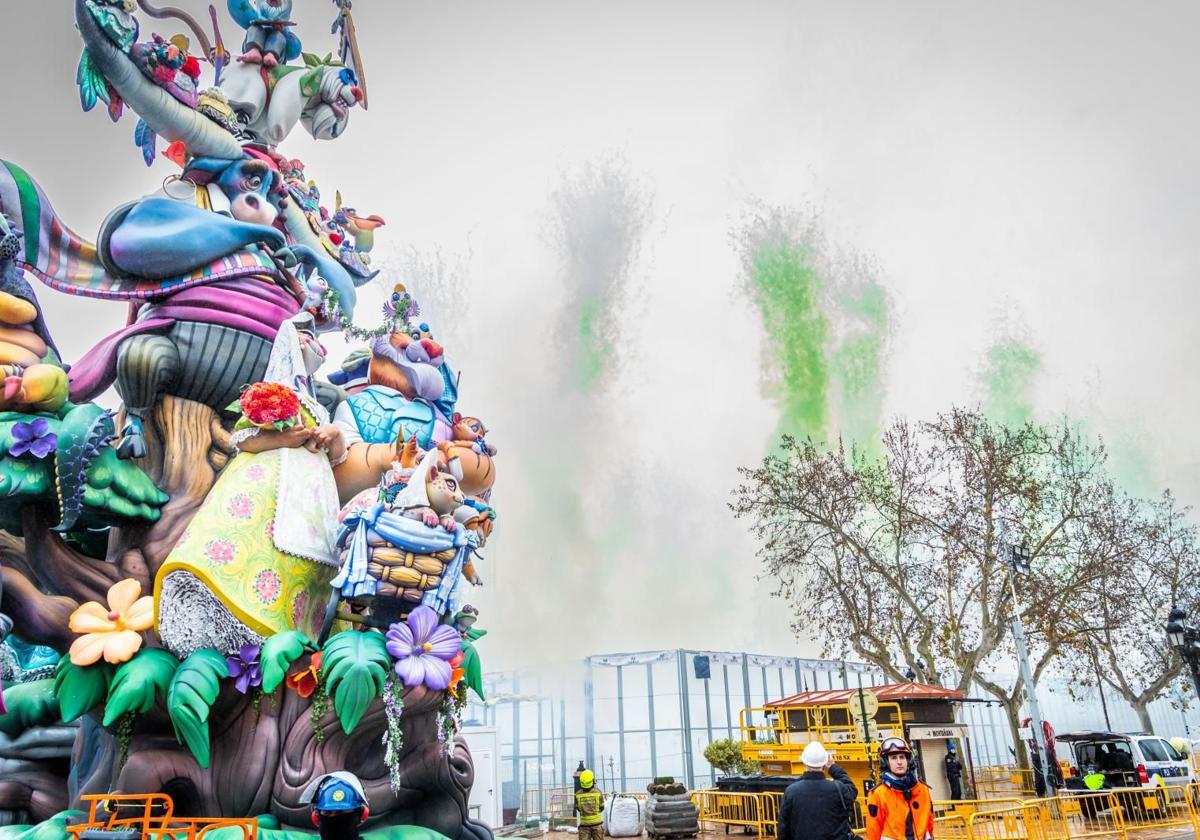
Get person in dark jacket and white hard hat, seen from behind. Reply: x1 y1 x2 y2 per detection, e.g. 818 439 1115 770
775 740 858 840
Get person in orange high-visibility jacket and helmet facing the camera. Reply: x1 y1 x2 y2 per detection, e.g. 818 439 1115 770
866 738 934 840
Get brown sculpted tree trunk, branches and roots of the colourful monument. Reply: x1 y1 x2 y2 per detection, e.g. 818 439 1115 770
0 397 491 840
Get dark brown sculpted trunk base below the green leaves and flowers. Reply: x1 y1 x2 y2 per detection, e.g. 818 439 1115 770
72 683 477 840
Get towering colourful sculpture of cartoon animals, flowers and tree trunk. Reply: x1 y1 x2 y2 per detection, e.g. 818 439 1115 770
0 0 497 840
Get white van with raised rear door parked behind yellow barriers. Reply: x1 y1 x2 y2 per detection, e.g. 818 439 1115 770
1055 732 1194 787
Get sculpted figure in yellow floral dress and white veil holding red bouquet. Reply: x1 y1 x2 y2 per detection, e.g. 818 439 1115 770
155 313 346 658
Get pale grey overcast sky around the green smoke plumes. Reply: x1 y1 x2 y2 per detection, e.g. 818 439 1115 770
0 0 1200 666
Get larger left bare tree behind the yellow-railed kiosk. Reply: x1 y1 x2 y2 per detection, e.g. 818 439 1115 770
731 409 1106 743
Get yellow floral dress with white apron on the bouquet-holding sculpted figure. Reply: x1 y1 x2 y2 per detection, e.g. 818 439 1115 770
155 410 338 640
